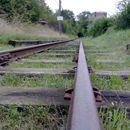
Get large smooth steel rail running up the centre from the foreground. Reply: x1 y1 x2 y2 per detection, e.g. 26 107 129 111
67 42 101 130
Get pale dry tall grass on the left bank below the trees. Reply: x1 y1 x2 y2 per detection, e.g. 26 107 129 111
0 19 68 43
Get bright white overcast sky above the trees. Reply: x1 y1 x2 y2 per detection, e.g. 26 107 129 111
45 0 121 16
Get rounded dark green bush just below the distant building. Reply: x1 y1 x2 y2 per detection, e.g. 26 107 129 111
88 18 112 37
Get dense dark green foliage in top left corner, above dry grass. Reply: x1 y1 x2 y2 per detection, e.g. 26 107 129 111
0 0 53 22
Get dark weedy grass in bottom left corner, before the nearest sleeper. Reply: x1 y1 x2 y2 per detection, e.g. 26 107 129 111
0 105 68 130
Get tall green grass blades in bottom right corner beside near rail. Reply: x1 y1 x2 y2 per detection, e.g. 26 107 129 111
99 108 130 130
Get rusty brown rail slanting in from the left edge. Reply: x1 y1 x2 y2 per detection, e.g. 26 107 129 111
0 39 75 65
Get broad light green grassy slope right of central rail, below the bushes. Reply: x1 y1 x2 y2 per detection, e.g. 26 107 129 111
84 30 130 70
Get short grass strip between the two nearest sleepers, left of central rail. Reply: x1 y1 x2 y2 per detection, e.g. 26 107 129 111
0 74 74 88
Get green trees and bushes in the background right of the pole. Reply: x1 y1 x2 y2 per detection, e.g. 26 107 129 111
62 0 130 37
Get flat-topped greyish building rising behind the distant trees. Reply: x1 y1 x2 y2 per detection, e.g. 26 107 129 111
90 12 107 20
